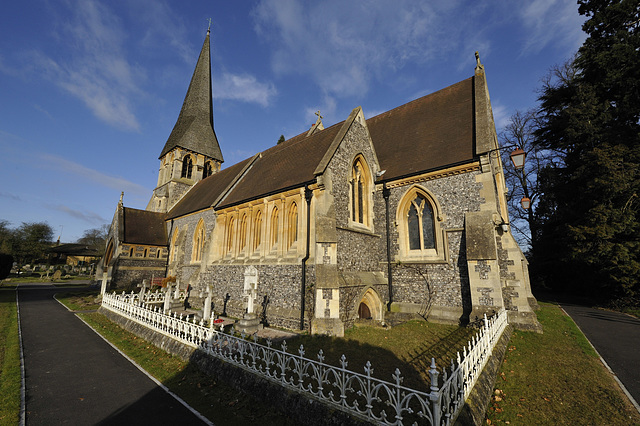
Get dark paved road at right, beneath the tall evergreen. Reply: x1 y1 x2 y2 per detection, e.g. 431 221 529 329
562 303 640 403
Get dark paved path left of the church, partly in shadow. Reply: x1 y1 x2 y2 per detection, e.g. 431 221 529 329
18 284 205 426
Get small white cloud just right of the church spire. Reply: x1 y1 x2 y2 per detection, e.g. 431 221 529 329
213 72 278 107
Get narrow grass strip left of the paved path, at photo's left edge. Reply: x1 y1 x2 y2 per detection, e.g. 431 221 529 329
0 290 22 425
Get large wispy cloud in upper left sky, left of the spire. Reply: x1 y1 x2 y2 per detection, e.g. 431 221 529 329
24 0 144 131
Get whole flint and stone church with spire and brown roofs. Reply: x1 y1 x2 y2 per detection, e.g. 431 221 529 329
97 33 540 336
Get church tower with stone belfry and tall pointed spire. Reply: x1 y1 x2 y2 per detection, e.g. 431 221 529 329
147 26 224 213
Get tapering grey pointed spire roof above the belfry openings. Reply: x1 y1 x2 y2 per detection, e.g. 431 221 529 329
159 24 224 162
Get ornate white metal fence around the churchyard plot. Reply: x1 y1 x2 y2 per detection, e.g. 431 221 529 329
102 293 507 426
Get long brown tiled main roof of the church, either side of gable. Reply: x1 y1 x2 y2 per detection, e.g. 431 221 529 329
168 73 476 218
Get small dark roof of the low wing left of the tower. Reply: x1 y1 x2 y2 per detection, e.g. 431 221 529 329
121 207 168 246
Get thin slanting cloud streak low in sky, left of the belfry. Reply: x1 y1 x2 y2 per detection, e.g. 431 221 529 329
38 154 150 196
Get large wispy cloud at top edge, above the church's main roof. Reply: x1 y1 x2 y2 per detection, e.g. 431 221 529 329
253 0 480 97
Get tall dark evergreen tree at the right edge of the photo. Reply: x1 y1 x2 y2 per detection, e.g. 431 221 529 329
534 0 640 304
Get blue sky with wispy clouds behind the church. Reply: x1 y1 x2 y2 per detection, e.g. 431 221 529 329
0 0 585 242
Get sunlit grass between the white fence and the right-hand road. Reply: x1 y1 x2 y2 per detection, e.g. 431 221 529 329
486 304 640 425
